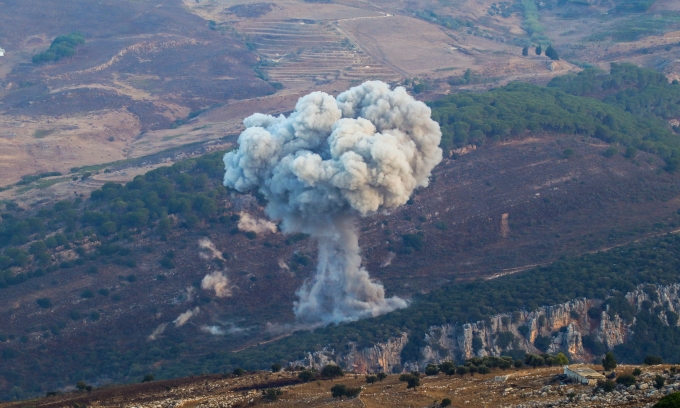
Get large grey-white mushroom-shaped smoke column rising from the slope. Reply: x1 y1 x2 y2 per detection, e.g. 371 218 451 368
224 81 442 324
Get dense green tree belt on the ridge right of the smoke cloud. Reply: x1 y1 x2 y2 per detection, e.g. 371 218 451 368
430 64 680 171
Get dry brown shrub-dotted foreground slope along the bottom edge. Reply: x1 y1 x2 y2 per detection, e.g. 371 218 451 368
0 366 678 408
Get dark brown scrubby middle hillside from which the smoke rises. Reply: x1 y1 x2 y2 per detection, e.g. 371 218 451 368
0 64 680 398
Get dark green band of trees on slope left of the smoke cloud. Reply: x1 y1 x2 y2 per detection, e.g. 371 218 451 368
0 152 234 288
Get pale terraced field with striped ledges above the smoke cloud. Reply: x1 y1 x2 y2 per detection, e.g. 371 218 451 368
236 20 399 88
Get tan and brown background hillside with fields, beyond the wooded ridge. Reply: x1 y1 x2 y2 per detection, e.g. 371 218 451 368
0 0 680 190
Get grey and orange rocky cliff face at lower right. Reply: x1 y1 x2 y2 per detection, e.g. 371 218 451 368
290 284 680 373
